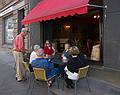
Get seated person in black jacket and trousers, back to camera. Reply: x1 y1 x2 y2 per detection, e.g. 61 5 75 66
64 46 87 88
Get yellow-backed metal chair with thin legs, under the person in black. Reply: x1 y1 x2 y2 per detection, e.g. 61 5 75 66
75 65 91 95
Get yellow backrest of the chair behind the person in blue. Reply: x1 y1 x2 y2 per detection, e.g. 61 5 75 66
33 68 47 81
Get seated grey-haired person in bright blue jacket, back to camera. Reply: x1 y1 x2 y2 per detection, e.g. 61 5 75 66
31 49 59 78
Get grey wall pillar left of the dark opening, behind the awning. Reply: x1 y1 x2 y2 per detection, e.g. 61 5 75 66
29 0 43 48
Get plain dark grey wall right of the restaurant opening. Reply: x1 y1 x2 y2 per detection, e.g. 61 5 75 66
103 0 120 70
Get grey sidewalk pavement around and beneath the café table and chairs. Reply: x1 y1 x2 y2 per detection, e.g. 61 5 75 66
0 48 120 95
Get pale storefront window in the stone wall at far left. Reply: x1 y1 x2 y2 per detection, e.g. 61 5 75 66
4 16 14 44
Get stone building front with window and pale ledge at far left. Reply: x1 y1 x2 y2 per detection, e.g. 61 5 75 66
0 0 28 48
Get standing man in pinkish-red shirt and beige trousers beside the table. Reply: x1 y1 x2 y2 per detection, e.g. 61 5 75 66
13 28 28 82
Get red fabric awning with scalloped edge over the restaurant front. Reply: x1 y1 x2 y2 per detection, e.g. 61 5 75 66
22 0 89 24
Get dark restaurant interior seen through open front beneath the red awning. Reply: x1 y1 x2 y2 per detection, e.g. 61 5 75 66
43 0 103 61
